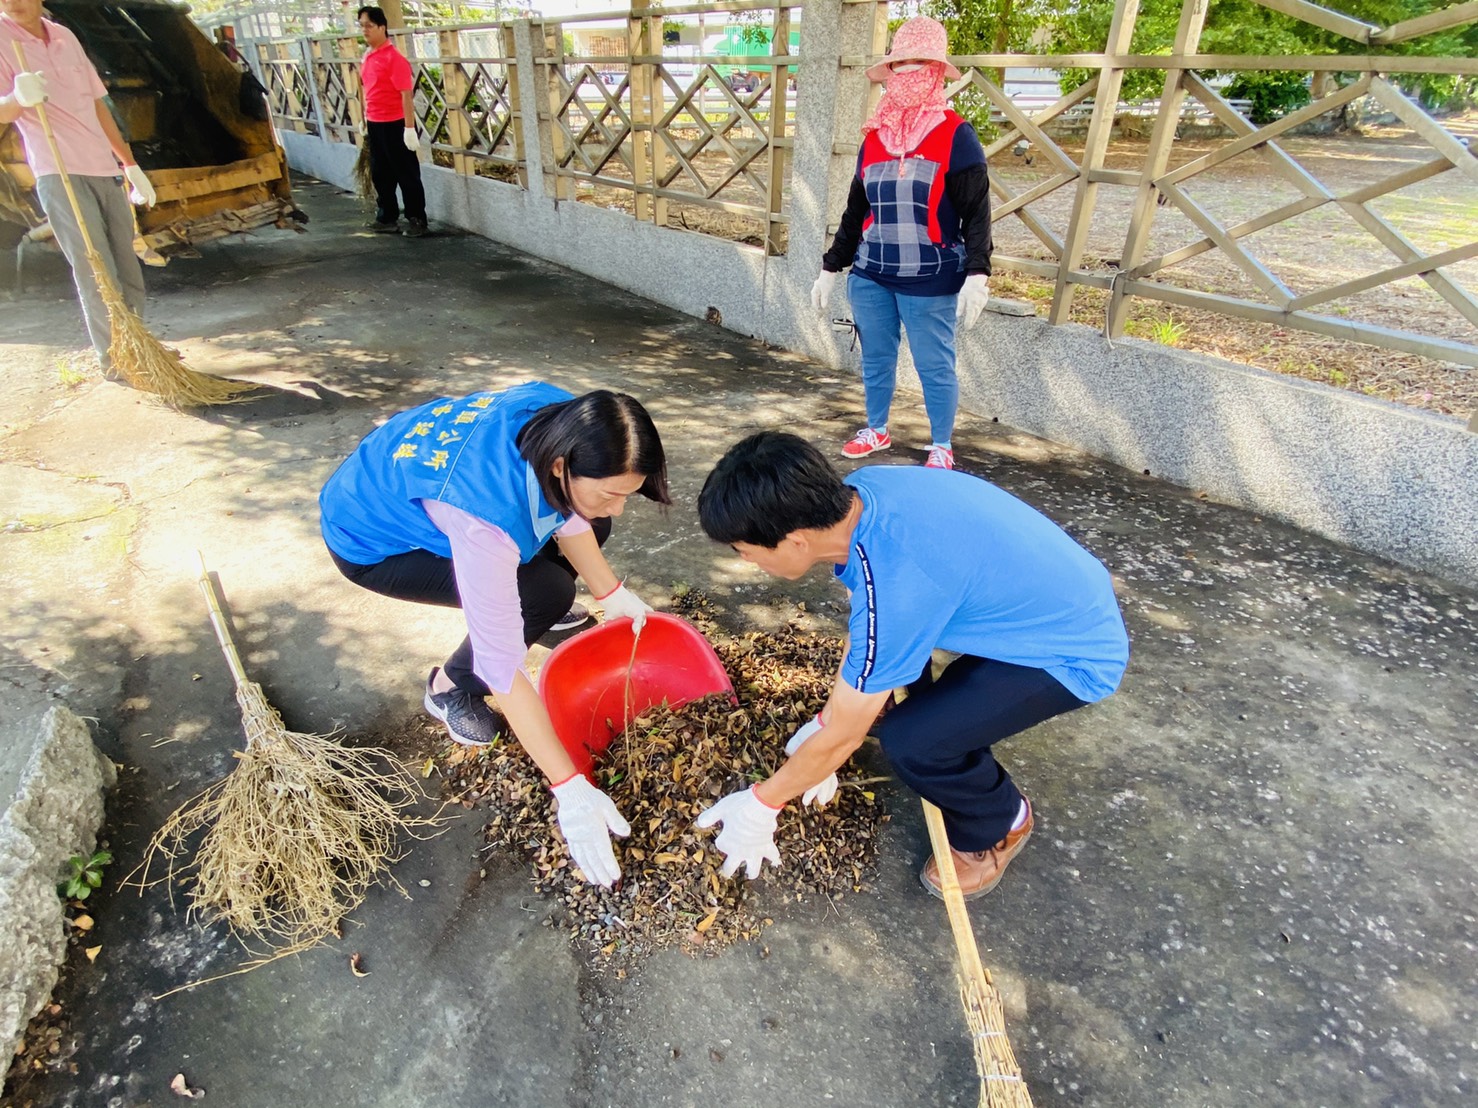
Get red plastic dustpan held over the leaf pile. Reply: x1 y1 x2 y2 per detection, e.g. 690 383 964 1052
539 612 733 774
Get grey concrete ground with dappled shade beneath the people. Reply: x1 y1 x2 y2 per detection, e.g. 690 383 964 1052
0 182 1478 1108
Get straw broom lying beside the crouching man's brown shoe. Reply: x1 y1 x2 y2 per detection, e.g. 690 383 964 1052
924 801 1032 1108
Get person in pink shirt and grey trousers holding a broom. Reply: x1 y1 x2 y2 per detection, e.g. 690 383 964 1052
0 0 155 377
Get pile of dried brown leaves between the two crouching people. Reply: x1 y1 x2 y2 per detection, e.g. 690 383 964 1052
431 594 887 959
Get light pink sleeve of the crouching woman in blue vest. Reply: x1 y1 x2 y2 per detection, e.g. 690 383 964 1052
421 501 528 693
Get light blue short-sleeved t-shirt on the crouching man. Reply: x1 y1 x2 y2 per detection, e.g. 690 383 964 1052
837 465 1129 702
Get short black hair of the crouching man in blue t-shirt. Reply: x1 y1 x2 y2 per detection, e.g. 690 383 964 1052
698 431 854 550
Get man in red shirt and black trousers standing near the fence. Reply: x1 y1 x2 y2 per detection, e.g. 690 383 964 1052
359 6 426 238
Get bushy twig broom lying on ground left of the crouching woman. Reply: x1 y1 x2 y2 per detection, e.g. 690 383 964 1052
130 561 439 984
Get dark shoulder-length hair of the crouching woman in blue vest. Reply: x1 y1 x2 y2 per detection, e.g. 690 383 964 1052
517 389 672 516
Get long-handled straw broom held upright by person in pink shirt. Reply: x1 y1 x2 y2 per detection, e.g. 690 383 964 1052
12 41 257 408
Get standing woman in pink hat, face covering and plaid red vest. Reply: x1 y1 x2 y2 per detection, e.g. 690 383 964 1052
811 15 990 470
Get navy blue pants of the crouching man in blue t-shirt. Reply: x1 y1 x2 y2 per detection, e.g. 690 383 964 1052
878 654 1086 851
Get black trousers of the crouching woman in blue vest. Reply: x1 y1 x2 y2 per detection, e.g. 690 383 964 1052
328 519 610 696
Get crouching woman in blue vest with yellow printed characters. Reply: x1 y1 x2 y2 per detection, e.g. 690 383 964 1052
326 381 671 885
